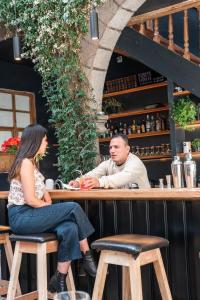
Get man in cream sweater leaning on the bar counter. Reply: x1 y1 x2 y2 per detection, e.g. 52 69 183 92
69 134 150 189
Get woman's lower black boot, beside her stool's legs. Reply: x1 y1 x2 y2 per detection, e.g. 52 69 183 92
48 271 67 293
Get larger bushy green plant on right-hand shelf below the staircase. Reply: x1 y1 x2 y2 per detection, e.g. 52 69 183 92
172 97 197 130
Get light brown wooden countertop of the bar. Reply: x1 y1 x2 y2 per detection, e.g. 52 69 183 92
0 188 200 201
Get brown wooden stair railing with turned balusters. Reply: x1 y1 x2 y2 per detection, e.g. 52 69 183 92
115 0 200 66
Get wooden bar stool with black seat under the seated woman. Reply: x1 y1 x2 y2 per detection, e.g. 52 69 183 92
7 233 75 300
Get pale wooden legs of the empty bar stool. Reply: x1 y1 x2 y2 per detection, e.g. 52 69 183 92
92 248 172 300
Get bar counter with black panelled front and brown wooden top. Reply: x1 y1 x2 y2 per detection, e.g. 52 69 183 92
0 188 200 300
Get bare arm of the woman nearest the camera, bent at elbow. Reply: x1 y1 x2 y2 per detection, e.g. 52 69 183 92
20 158 49 208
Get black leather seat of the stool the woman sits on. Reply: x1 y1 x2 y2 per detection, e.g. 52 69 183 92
10 232 57 243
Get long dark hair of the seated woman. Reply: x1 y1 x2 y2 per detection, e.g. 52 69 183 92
9 124 47 180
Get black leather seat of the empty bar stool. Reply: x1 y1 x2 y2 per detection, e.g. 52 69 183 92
91 234 169 255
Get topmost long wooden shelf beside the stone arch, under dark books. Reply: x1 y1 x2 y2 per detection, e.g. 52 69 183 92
103 81 167 99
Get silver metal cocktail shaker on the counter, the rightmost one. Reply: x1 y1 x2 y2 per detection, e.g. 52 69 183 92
184 153 196 188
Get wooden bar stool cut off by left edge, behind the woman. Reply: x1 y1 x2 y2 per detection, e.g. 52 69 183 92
0 225 21 295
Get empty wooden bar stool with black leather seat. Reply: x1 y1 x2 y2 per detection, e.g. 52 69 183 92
91 234 172 300
